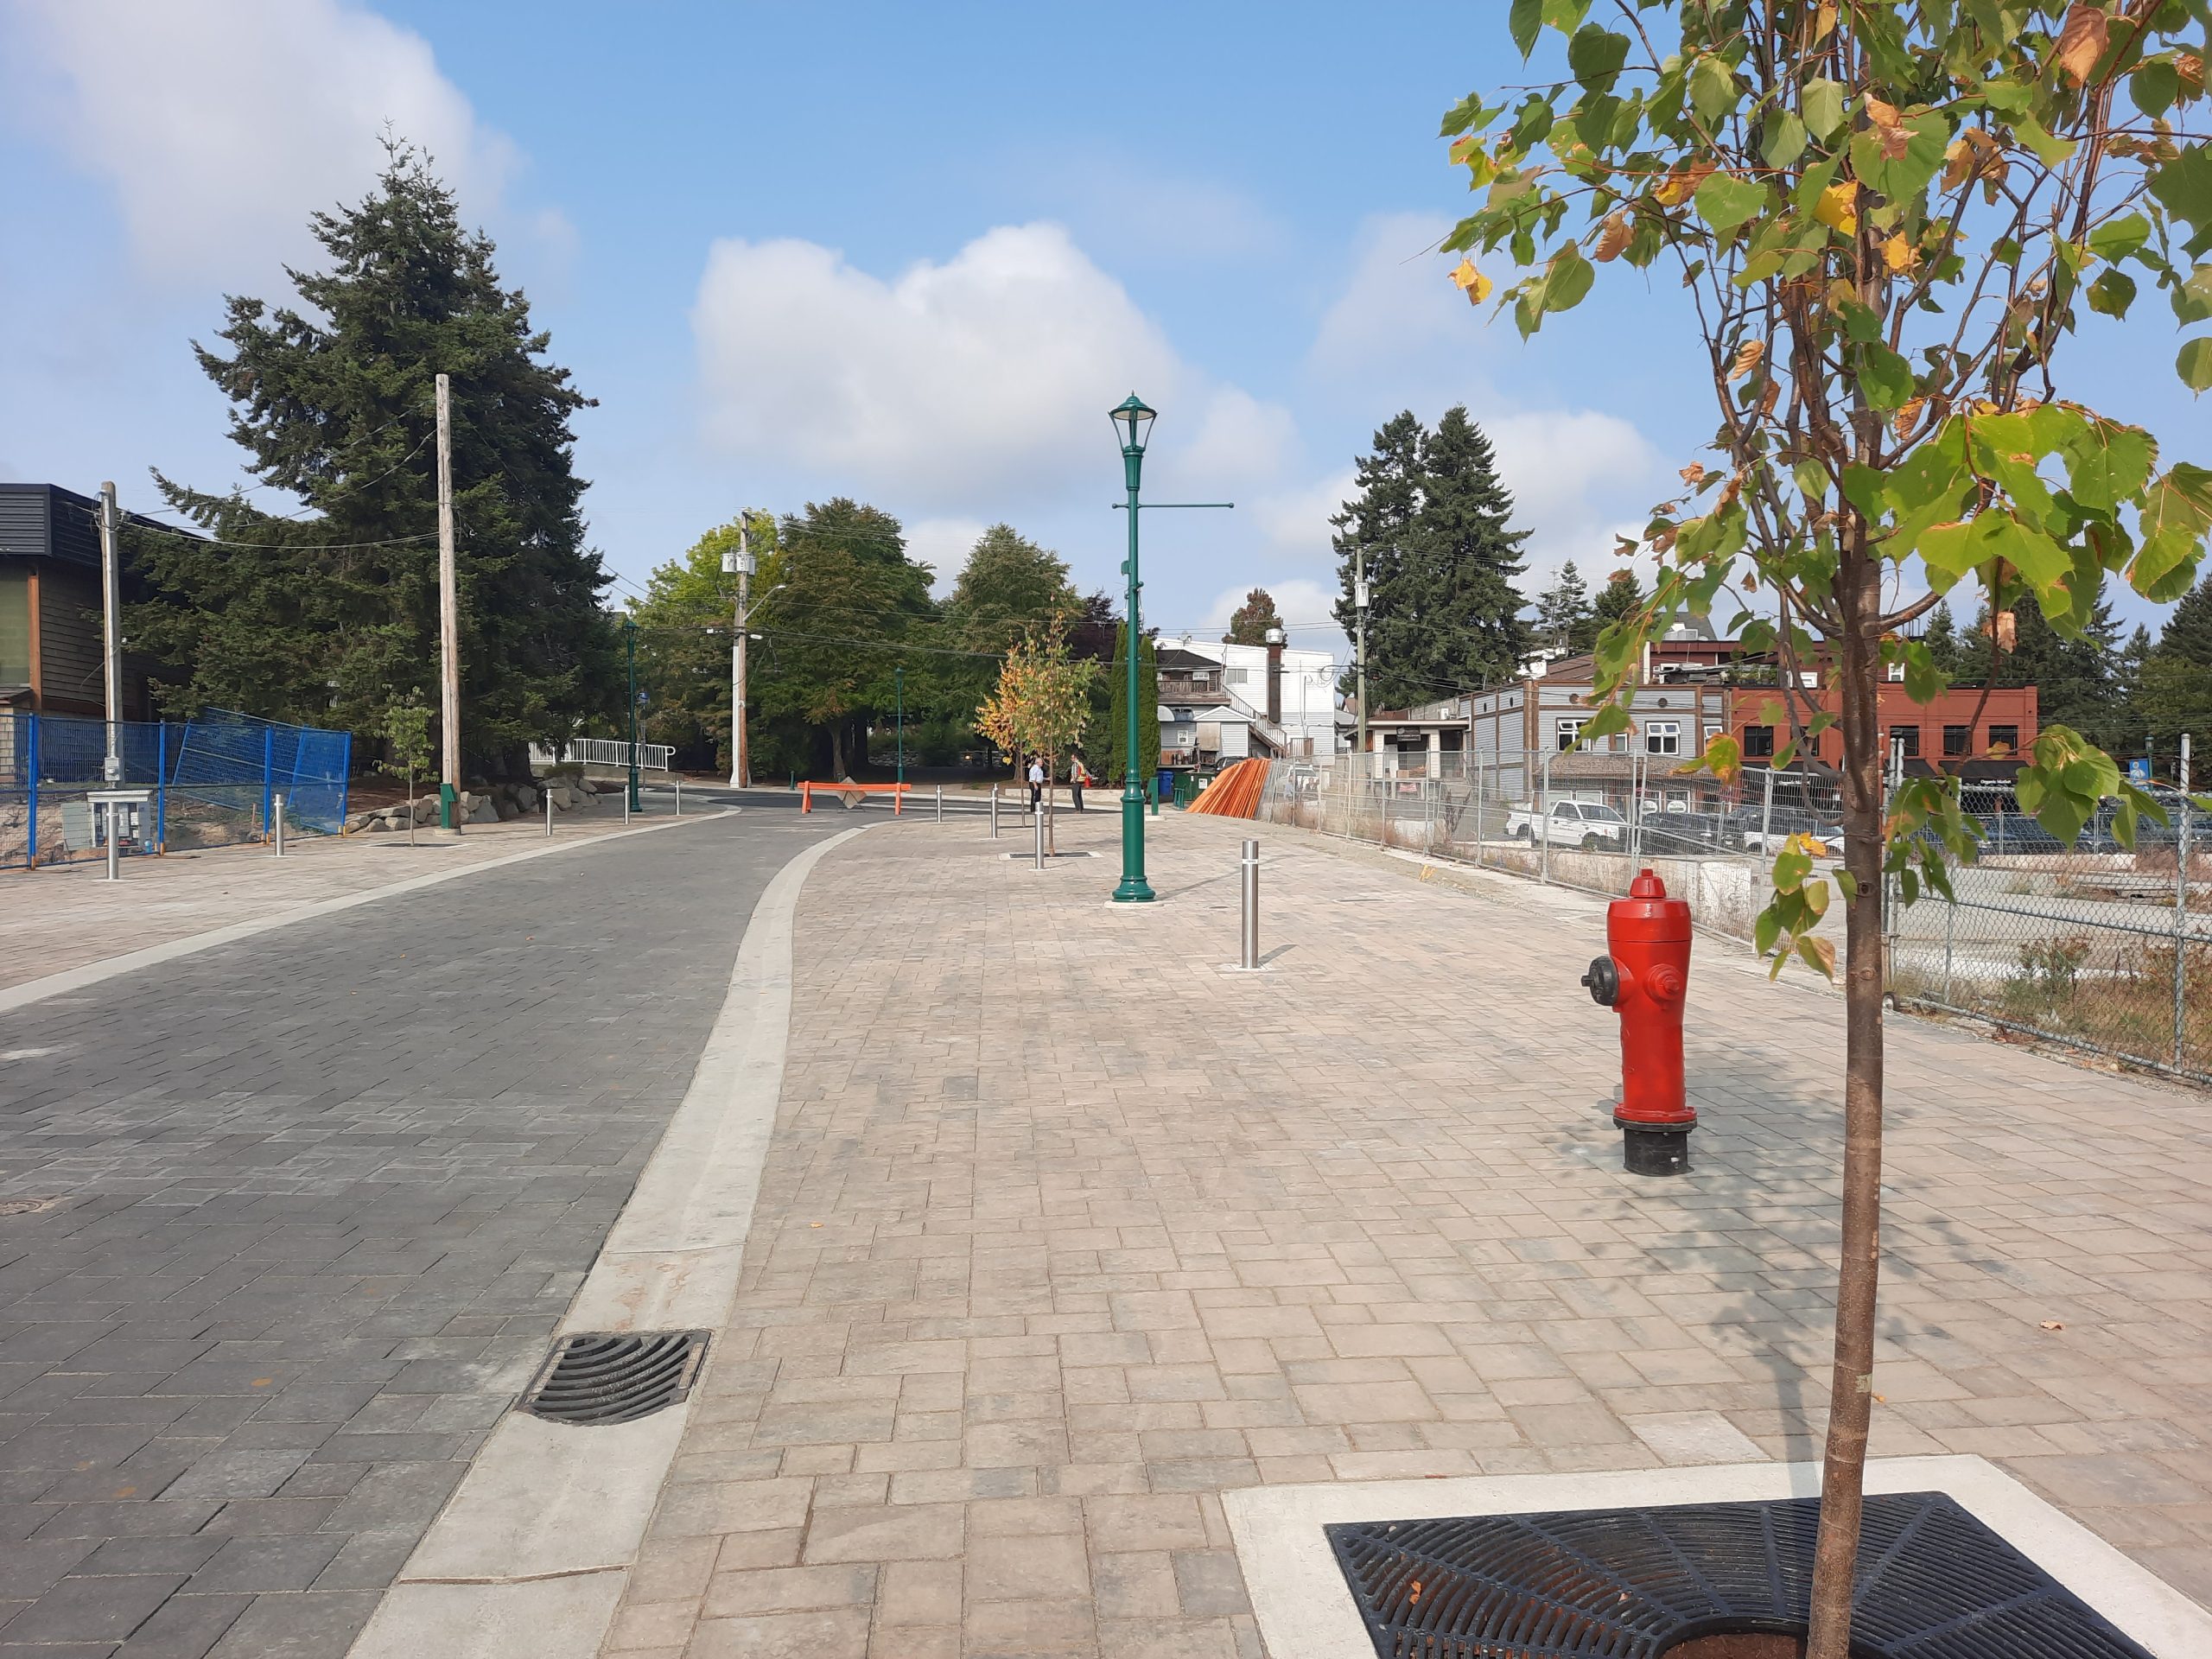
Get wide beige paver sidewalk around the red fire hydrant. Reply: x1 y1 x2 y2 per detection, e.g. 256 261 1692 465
611 814 2212 1659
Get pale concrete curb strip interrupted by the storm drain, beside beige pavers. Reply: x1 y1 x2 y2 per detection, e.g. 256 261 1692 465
352 825 869 1659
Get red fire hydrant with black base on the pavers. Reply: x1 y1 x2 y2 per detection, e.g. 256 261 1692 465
1581 869 1697 1174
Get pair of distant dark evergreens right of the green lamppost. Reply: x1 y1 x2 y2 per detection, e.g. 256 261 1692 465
1332 407 1529 708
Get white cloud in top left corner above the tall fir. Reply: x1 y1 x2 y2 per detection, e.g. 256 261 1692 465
0 0 515 283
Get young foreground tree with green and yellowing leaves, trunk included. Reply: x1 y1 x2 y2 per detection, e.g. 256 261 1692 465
1445 0 2212 1659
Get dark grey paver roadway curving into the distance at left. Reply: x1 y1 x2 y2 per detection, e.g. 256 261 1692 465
0 814 852 1659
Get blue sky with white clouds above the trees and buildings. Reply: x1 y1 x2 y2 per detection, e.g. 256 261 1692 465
0 0 2208 677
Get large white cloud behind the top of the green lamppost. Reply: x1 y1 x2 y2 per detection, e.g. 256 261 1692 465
692 224 1294 511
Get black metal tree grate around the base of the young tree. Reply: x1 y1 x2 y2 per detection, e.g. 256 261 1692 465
1327 1493 2152 1659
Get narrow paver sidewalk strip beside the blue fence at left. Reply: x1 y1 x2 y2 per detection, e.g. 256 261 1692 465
0 794 694 988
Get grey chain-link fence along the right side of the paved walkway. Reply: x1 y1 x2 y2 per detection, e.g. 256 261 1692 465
1256 750 2212 1082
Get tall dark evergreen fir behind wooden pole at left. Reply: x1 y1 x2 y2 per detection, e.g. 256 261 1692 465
128 142 621 777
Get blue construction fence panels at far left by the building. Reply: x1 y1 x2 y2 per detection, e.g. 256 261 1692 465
0 708 354 869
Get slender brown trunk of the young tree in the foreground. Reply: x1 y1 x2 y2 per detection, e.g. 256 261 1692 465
1805 522 1885 1659
